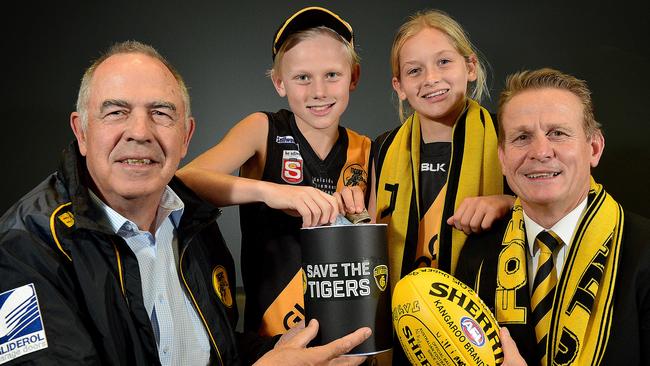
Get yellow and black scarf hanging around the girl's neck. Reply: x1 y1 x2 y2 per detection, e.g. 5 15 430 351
377 99 503 286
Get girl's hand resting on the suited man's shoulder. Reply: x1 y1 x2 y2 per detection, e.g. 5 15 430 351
447 195 515 235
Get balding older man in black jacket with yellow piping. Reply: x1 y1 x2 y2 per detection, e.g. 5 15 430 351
0 42 369 365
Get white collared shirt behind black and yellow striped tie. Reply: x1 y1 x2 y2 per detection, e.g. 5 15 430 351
524 198 587 291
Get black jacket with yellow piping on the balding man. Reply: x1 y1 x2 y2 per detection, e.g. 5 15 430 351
0 143 272 365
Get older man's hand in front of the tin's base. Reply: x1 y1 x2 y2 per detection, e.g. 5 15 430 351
255 319 371 366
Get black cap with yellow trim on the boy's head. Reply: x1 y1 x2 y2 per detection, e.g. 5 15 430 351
273 6 354 60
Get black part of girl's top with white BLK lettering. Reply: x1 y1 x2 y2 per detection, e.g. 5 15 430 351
420 140 451 219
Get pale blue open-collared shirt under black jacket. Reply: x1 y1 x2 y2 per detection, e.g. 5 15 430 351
89 186 210 366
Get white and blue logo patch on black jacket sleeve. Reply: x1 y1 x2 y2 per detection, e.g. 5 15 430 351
0 283 47 365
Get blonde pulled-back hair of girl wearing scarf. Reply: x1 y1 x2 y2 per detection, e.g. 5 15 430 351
390 10 490 120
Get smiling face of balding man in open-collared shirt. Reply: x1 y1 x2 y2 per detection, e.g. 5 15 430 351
71 53 194 205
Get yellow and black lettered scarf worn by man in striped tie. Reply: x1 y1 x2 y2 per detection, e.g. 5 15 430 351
495 178 623 365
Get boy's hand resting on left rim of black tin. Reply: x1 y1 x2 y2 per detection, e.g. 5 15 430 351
260 181 339 227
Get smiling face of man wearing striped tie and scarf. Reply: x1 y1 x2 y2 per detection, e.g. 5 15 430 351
499 88 604 214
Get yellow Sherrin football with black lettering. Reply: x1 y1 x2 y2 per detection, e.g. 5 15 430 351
392 268 503 366
